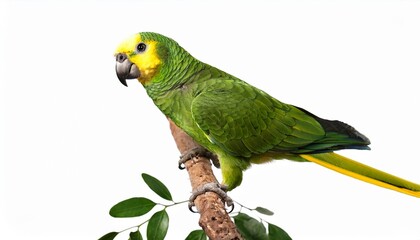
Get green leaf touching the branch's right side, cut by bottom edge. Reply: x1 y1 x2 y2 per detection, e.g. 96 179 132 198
233 213 268 240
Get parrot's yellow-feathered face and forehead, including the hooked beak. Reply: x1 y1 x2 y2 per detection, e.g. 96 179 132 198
115 33 162 86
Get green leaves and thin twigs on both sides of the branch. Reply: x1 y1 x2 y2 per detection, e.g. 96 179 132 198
99 173 291 240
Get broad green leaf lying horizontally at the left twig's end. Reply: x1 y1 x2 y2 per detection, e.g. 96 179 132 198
109 197 156 217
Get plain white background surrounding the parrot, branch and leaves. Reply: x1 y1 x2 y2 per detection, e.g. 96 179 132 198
0 0 420 240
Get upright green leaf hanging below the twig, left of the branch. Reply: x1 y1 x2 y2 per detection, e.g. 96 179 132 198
147 209 169 240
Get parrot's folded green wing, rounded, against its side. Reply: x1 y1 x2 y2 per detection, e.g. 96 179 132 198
191 81 325 157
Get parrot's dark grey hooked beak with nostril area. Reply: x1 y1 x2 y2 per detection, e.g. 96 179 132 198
115 53 140 87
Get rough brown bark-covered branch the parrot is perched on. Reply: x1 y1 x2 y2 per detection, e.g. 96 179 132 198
169 120 242 240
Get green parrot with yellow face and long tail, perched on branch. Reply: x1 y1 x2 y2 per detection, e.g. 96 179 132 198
115 32 420 197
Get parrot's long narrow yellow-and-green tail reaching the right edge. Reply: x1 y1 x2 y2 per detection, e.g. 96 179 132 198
300 152 420 198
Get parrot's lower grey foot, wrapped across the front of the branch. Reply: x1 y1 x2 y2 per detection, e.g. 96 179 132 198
188 182 235 213
